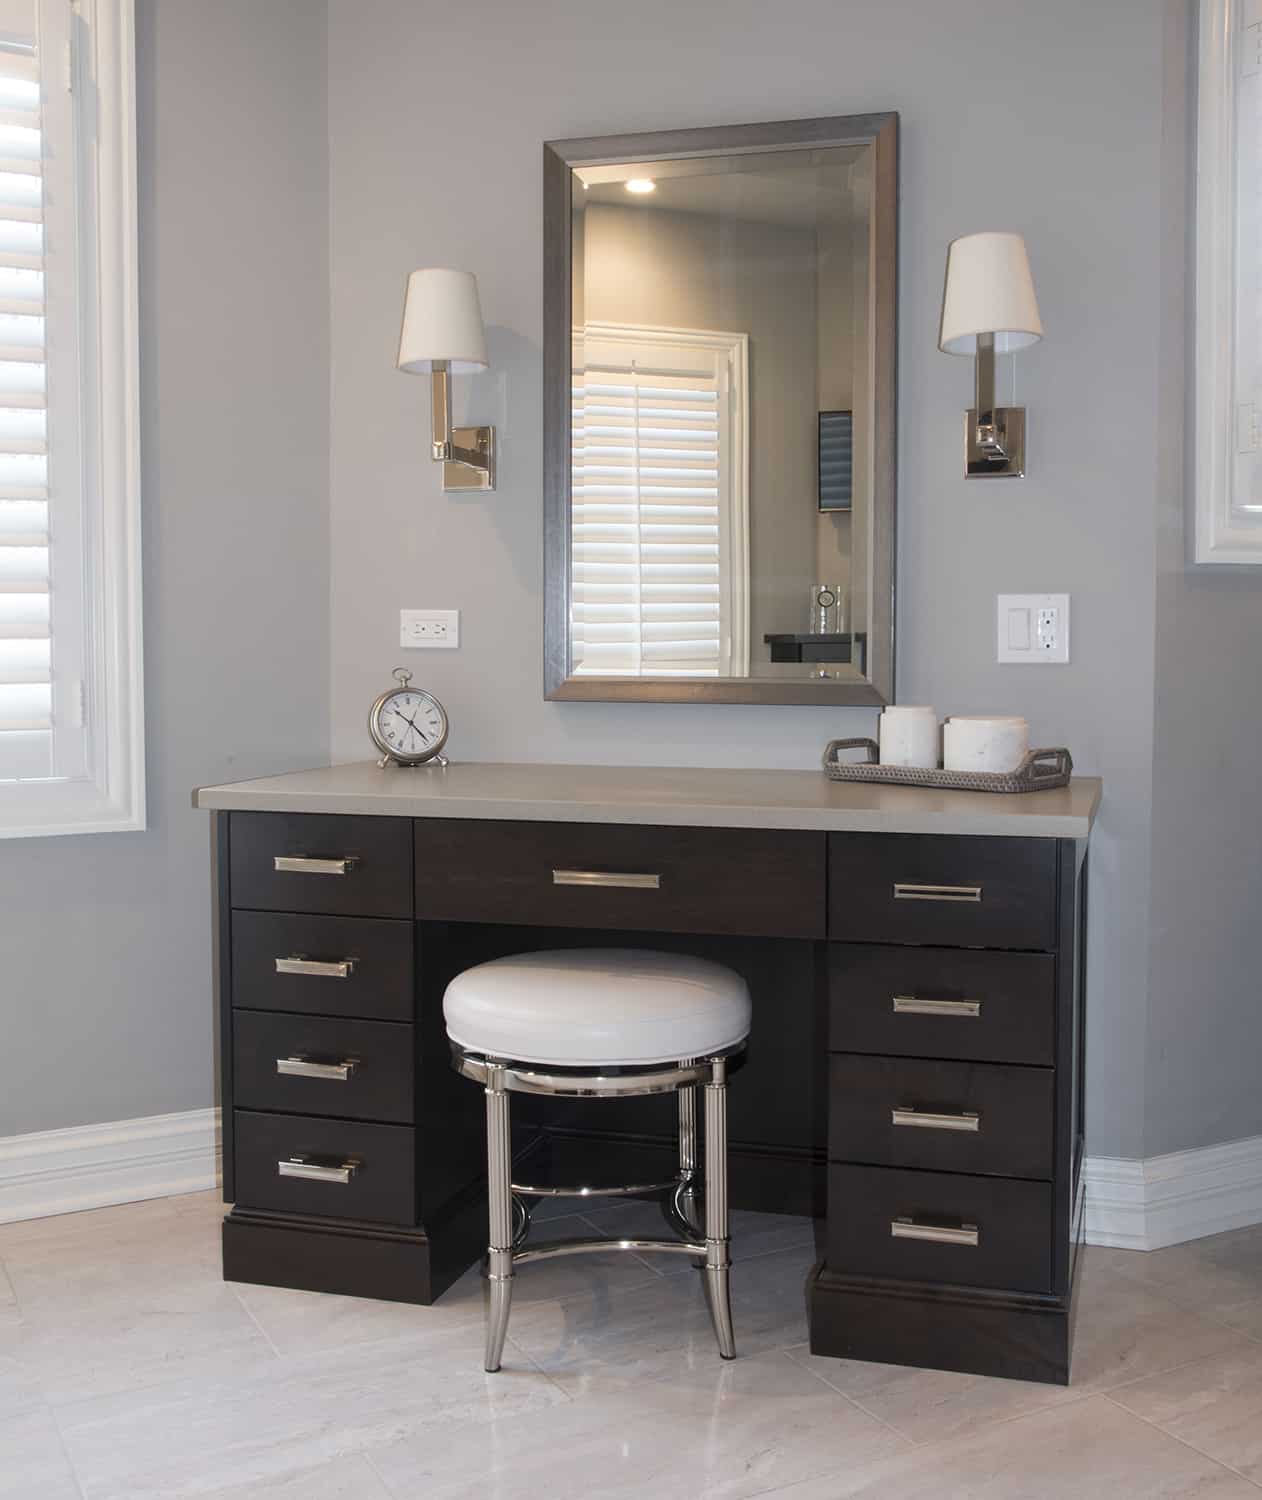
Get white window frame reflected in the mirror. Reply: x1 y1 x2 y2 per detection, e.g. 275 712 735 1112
570 321 750 680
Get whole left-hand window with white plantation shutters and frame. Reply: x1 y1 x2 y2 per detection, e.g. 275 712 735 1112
0 0 144 837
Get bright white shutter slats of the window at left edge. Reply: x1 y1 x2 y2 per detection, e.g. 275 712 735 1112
0 38 53 779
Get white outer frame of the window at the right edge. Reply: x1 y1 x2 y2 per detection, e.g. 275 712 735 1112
1193 0 1262 564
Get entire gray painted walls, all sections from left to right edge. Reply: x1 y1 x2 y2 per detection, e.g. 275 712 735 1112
0 0 1262 1157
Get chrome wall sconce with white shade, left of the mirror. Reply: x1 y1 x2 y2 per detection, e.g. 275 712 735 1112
398 269 495 491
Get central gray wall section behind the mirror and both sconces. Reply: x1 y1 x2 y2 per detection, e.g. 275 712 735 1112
329 0 1164 1157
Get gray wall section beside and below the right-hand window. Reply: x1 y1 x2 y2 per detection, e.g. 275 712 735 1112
1143 0 1262 1157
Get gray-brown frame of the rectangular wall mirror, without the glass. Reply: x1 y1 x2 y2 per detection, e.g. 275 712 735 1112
543 113 899 705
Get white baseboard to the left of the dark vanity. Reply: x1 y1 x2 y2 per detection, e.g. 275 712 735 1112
0 1110 221 1224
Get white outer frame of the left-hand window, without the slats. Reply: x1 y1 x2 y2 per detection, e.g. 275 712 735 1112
0 0 146 839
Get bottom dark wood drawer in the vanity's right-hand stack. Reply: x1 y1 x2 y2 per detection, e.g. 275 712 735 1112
828 1163 1052 1292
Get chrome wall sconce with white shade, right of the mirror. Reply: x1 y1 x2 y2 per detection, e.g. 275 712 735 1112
938 234 1043 479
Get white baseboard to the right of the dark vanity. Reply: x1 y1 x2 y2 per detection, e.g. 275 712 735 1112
1083 1136 1262 1250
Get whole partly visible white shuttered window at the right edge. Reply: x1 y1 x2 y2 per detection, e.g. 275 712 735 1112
1194 0 1262 563
